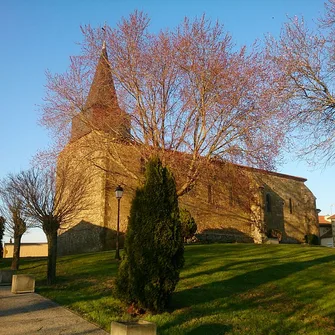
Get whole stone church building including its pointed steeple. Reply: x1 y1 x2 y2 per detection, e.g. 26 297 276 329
58 45 319 255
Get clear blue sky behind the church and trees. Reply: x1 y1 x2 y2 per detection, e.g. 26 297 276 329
0 0 335 241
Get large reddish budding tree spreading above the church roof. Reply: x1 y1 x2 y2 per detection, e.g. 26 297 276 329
41 12 286 195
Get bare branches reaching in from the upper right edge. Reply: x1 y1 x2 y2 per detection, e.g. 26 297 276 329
267 0 335 164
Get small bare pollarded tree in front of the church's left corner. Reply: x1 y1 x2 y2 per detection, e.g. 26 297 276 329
11 165 89 284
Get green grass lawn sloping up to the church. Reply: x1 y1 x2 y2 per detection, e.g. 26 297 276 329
0 244 335 335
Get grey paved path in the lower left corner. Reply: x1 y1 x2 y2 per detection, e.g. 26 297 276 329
0 286 108 335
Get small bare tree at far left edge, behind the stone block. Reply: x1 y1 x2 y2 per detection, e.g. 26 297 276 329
0 177 32 270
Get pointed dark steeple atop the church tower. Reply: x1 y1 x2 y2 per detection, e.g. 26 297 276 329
71 41 130 141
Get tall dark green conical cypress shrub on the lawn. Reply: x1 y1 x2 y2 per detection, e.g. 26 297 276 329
116 158 184 313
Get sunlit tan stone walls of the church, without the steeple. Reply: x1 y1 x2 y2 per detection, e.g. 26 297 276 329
58 134 318 254
